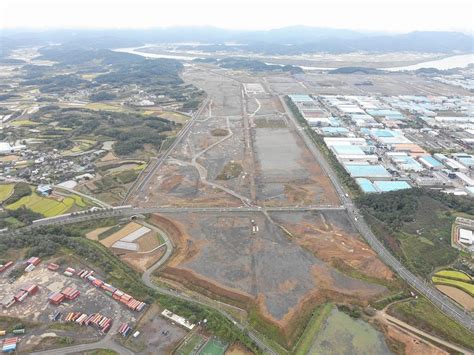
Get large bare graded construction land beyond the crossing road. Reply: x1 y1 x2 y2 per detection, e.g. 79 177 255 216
129 67 339 207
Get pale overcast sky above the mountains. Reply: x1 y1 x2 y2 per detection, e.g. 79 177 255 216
0 0 474 33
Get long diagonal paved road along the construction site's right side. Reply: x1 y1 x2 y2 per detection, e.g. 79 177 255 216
280 96 474 331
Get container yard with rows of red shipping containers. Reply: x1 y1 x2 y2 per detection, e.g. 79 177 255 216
0 259 141 352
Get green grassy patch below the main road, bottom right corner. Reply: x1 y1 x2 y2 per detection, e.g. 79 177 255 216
388 297 474 349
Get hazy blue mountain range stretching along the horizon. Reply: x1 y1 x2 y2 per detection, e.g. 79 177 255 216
0 26 474 55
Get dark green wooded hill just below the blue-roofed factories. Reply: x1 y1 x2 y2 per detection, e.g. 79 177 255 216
356 188 474 277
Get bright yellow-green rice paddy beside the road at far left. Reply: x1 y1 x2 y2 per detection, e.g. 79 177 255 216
6 192 87 217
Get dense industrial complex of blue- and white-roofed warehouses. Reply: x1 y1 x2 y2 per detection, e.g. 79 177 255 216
289 94 474 195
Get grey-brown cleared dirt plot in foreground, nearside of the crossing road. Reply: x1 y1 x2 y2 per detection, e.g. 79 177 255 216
152 213 386 334
